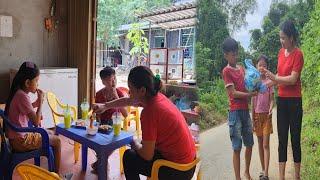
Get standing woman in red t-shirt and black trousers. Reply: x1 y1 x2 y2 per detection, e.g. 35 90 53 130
264 21 303 180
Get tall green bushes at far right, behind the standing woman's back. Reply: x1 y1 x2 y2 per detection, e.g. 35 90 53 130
301 1 320 179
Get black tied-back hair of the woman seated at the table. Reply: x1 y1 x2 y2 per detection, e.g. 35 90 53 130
128 66 162 97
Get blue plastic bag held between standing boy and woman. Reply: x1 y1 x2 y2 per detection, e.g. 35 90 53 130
244 59 267 93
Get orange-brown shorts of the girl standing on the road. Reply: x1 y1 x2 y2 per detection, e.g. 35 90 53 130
253 113 273 136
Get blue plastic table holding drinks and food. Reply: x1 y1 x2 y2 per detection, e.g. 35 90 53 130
56 123 133 180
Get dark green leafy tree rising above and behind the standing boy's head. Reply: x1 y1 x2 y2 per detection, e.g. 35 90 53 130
196 0 256 80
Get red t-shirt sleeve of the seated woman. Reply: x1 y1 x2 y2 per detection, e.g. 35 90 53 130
141 111 157 141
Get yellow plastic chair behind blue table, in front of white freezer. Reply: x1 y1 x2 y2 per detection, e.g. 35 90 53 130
47 92 81 163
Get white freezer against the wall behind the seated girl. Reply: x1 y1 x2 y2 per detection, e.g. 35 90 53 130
10 67 78 128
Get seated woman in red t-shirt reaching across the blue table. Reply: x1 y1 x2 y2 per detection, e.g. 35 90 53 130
94 66 196 180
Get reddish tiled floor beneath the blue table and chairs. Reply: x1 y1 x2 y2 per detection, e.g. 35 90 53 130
13 136 145 180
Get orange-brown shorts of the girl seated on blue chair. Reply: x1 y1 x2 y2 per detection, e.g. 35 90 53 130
10 133 42 152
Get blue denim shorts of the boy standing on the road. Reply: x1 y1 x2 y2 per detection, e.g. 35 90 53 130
228 110 253 150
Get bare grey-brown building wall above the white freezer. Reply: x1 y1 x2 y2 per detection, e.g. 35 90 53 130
0 0 68 103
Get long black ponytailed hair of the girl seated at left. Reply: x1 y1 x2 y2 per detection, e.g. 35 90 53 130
5 62 40 115
